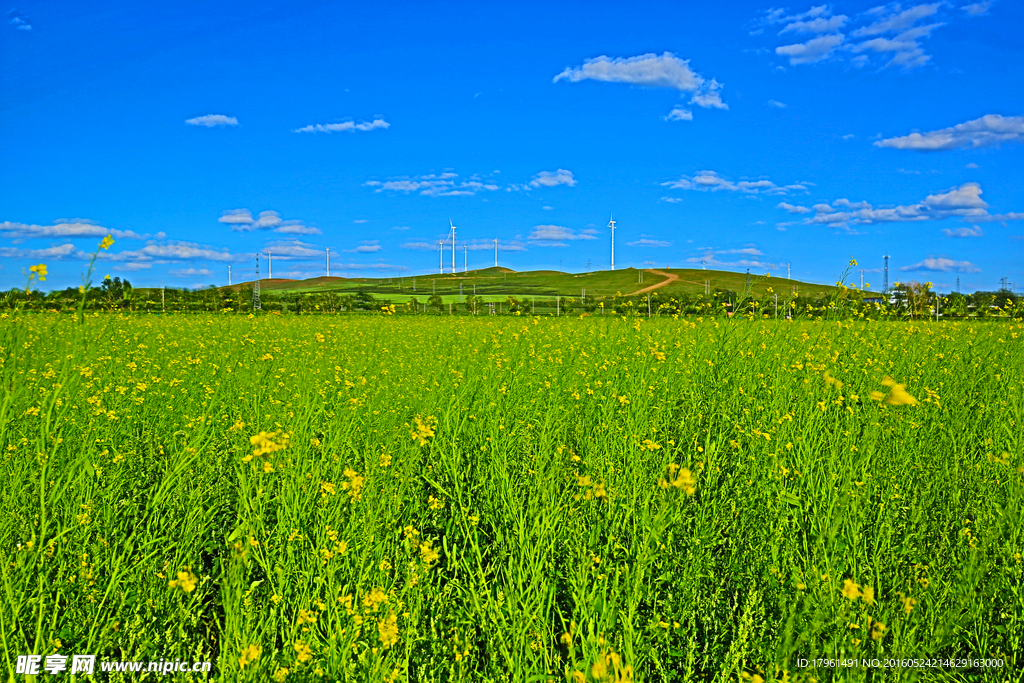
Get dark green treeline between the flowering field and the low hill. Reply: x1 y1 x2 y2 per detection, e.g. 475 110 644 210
0 278 1024 319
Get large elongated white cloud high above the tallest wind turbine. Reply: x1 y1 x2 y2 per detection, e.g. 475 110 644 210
553 52 728 116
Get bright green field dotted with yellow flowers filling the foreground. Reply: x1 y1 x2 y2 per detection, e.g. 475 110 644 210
0 315 1024 683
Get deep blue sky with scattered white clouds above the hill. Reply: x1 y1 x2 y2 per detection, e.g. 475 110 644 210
0 0 1024 291
